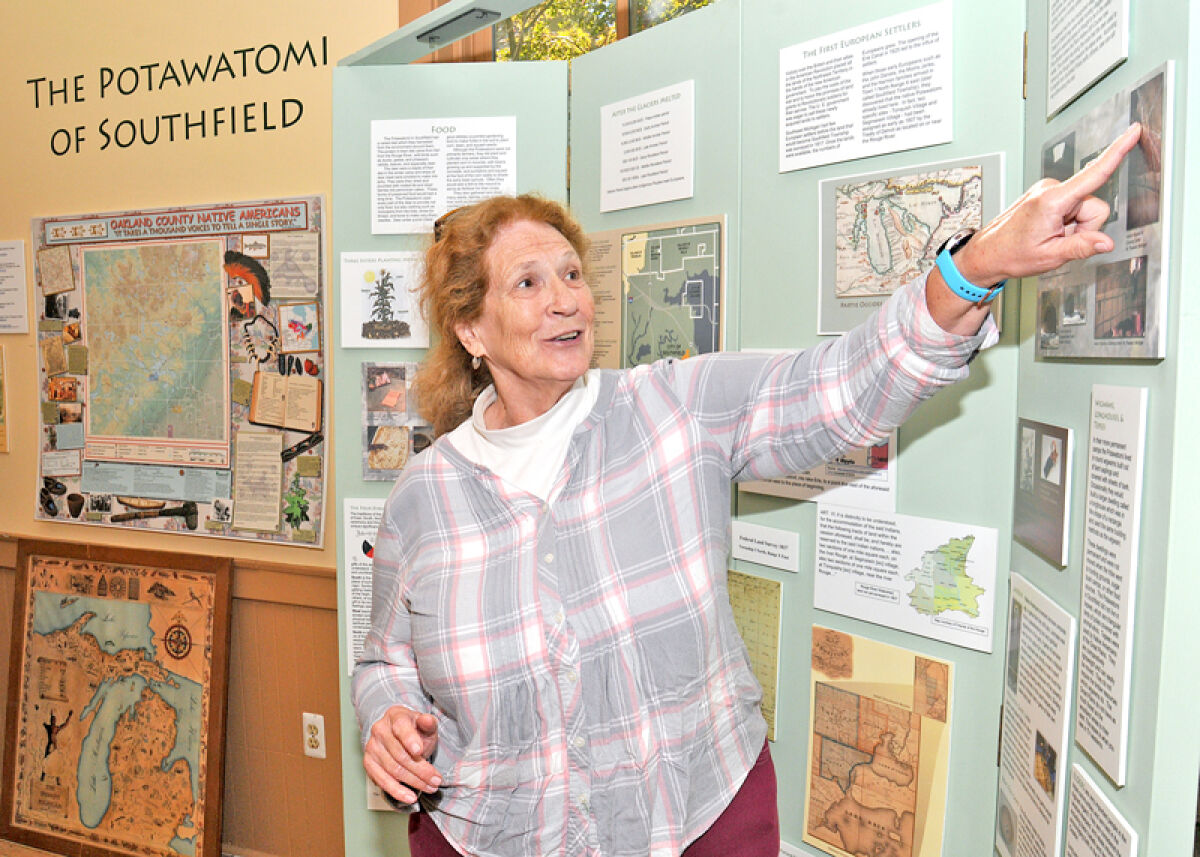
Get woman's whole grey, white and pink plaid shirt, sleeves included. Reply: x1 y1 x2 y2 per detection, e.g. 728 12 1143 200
353 282 995 857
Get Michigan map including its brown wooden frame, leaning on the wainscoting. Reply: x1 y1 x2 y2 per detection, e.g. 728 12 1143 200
0 540 232 857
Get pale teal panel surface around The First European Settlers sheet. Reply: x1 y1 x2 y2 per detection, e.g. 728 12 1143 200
738 0 1025 855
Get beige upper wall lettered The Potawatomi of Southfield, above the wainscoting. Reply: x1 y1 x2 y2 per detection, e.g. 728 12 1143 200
0 0 397 568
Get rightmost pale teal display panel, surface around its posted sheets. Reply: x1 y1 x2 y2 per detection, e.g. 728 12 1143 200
1012 0 1200 855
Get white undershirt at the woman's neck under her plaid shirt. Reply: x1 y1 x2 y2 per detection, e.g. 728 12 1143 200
446 370 600 503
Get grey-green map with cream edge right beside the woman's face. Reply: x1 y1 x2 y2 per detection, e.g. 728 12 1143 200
620 223 722 366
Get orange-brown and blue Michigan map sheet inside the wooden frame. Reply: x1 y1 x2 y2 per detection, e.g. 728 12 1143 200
11 558 214 857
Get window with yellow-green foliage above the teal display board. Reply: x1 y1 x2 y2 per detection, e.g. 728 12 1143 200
492 0 714 61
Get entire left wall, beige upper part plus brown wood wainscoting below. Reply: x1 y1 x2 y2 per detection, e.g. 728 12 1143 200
0 0 398 857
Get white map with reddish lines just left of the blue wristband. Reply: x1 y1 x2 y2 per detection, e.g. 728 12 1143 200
834 167 983 298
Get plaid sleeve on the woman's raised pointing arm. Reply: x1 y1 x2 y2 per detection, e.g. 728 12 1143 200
665 273 998 481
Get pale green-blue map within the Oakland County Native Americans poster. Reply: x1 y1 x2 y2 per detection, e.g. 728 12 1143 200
82 239 229 443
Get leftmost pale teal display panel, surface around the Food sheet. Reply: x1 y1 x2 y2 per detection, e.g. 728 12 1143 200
330 62 566 857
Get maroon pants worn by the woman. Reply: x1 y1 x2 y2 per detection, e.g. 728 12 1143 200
408 742 779 857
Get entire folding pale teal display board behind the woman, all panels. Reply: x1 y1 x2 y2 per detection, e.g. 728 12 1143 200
332 0 1200 857
